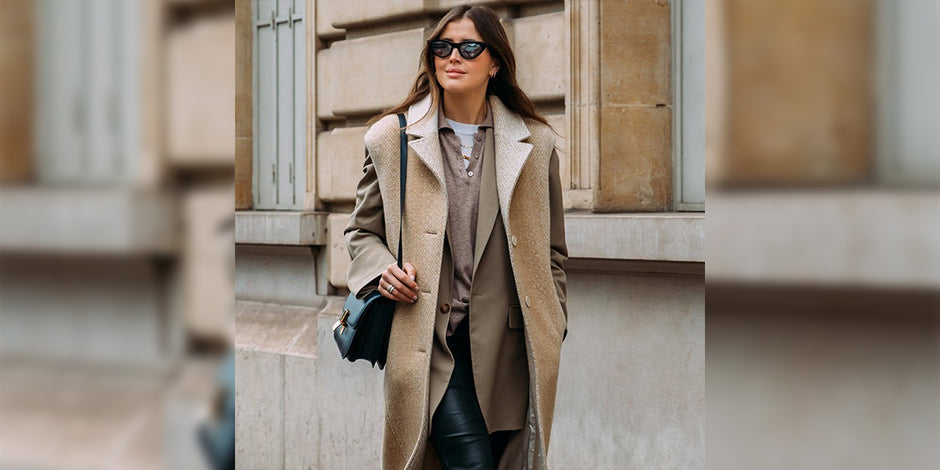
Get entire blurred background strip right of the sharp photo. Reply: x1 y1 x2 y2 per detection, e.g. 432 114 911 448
705 0 940 469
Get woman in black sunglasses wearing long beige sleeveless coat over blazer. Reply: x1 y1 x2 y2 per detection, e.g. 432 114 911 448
345 6 567 469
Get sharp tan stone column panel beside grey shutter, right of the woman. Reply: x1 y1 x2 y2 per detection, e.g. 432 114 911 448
593 0 672 212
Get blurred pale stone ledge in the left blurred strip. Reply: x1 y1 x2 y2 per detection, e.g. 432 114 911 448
0 187 180 256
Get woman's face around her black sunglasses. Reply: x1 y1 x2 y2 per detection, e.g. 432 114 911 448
432 17 499 94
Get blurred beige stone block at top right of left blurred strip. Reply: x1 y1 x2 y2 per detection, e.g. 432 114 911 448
165 12 235 165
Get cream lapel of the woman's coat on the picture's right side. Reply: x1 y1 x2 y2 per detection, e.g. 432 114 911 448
490 96 532 224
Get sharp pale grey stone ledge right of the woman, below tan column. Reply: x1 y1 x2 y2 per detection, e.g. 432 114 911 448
565 212 705 263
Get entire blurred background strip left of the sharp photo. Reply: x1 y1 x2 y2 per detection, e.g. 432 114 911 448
0 0 235 469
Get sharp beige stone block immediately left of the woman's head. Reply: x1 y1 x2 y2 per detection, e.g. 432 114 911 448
317 28 424 119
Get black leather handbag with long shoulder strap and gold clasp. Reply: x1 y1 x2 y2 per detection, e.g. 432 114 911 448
333 114 408 369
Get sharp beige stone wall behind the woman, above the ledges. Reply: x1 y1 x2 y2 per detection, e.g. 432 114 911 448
236 0 688 212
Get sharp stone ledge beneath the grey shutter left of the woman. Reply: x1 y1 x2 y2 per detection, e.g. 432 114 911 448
235 211 329 245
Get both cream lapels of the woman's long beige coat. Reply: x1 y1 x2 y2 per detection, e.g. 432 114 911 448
406 95 533 227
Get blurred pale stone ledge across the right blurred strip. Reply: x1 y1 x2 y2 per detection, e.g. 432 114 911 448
706 190 940 289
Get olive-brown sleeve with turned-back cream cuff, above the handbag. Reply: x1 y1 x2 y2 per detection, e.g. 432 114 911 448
343 150 395 298
